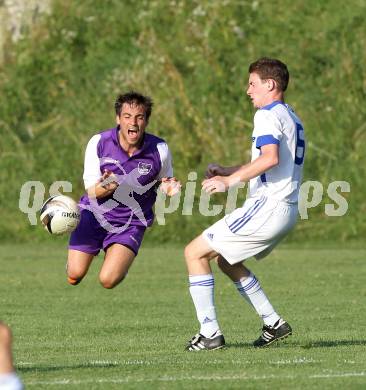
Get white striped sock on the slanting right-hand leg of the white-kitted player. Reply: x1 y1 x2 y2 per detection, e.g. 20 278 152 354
234 273 280 326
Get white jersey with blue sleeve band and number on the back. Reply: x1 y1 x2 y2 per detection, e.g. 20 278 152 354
249 101 305 203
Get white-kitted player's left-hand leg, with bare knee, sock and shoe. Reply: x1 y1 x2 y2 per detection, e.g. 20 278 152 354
185 236 225 351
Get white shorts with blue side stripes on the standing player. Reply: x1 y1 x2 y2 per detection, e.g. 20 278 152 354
202 196 298 264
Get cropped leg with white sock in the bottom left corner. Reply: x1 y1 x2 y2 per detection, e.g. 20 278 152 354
0 321 23 390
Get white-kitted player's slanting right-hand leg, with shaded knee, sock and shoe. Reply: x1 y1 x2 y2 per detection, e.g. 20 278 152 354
217 256 292 347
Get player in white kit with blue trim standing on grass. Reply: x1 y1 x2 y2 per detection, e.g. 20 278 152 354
185 58 305 351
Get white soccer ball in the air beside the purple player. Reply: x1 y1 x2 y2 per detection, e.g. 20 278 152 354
40 195 80 234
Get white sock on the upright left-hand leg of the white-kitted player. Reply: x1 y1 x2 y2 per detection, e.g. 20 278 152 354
189 274 219 337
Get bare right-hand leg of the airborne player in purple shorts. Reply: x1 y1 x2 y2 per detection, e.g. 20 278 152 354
99 244 136 288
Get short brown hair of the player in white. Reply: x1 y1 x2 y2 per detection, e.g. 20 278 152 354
249 57 290 91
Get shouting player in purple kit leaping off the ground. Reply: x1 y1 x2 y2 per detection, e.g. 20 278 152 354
67 92 180 288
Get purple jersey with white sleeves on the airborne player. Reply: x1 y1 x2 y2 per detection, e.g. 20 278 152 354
80 127 173 231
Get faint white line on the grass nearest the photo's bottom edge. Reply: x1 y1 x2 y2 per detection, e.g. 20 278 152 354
25 371 366 386
